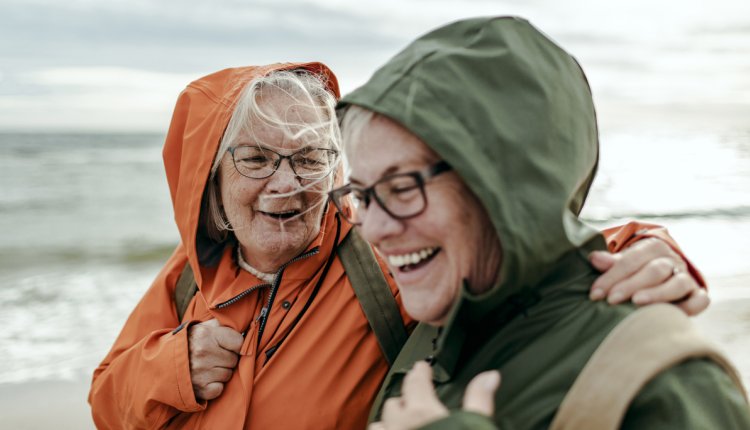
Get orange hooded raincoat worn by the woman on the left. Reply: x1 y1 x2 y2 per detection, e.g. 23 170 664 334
89 63 704 429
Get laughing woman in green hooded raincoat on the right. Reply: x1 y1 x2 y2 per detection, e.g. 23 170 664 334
331 18 750 429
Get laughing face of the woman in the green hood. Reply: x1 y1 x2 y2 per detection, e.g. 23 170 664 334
345 116 502 325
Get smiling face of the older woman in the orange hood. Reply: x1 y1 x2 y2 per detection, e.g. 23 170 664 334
218 88 333 272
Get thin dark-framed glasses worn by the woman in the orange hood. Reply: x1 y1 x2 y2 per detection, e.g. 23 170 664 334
227 145 339 179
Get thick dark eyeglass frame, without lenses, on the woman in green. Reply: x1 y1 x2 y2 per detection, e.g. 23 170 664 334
328 160 453 225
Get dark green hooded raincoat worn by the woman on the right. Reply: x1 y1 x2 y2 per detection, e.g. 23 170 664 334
342 17 750 430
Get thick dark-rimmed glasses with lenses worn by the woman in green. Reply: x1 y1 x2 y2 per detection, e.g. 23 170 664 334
328 161 452 225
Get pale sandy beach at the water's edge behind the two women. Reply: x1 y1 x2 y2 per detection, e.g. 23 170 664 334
0 277 750 430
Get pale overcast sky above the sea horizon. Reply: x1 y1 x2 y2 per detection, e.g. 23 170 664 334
0 0 750 132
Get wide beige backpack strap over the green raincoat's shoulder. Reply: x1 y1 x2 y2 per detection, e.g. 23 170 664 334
550 304 747 430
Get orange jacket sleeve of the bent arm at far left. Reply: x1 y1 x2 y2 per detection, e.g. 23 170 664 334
89 249 205 429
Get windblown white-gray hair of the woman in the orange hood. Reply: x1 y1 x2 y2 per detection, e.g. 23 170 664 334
202 70 341 242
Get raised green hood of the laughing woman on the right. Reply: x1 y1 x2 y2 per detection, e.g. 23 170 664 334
341 17 603 326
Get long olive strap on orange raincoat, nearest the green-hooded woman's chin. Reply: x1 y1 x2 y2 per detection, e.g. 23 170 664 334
337 229 409 366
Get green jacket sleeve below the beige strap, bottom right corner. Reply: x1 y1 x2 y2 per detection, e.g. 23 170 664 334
622 359 750 430
